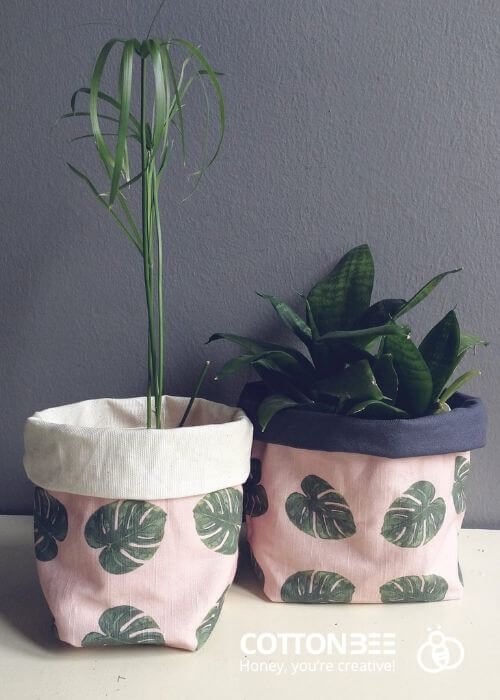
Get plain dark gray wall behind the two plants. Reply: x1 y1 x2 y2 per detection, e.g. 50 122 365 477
0 0 500 527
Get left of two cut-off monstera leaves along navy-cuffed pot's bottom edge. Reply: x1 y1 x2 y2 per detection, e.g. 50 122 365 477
281 571 355 603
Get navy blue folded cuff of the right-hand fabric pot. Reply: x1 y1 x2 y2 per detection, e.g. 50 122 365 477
238 382 486 458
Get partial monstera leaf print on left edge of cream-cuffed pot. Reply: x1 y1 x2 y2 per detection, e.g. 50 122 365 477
33 486 68 561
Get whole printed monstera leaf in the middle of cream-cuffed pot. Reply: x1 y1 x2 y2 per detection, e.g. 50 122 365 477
84 500 167 574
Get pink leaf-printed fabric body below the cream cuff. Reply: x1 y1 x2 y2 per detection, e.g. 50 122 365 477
35 486 241 650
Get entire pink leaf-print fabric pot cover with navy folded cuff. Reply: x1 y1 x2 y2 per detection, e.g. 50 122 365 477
239 383 486 603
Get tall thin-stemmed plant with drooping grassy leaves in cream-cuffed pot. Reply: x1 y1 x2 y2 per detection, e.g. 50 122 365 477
63 9 225 428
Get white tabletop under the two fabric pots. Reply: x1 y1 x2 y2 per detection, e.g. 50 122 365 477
0 515 500 700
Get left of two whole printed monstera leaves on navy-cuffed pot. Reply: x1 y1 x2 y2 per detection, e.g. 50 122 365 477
285 474 356 540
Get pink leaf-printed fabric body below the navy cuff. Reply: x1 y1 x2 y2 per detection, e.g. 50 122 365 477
245 442 469 603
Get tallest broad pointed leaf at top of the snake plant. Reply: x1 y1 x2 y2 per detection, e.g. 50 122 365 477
307 244 374 335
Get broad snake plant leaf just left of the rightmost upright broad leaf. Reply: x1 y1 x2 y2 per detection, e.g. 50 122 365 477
384 335 432 416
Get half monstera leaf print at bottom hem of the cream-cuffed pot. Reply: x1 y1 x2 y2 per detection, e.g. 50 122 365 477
82 605 165 647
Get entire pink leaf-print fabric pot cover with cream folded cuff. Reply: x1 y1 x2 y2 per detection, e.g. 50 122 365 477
24 397 252 650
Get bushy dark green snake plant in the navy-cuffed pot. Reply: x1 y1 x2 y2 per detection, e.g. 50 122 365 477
208 245 487 430
